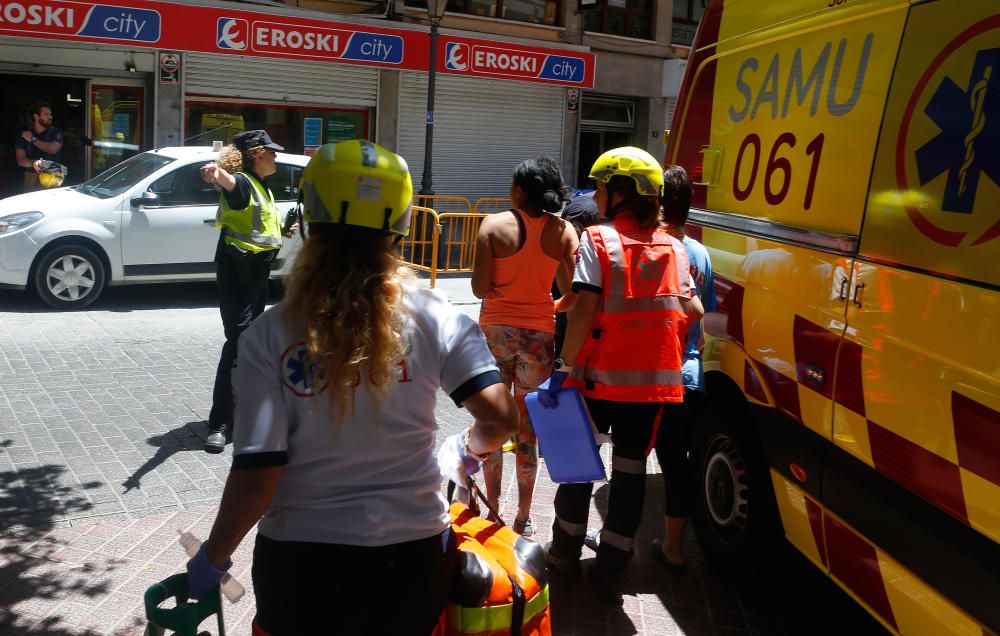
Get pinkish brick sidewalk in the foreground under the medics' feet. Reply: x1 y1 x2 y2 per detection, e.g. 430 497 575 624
0 449 780 636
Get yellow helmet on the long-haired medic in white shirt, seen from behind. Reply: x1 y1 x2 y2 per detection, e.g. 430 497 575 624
299 139 413 236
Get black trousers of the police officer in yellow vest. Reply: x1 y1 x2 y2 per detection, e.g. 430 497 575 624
208 239 277 431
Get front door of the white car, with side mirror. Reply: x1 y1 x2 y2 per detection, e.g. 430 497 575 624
122 161 219 279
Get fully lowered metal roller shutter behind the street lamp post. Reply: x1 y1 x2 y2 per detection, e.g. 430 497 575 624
399 73 566 203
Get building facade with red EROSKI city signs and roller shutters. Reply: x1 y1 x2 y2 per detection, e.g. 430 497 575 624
0 0 699 199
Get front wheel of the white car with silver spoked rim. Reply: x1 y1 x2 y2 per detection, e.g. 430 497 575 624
35 245 105 309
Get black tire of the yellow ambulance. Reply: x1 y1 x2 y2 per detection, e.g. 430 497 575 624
690 403 787 579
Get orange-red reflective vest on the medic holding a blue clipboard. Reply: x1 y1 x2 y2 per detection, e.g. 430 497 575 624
566 214 691 402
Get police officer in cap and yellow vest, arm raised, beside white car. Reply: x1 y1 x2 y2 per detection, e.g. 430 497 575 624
201 130 297 453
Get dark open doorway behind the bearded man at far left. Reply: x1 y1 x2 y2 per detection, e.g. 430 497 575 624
0 73 87 198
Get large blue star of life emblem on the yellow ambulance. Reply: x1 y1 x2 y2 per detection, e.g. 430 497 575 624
916 48 1000 214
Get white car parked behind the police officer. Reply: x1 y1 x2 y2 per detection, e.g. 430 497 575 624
0 146 309 309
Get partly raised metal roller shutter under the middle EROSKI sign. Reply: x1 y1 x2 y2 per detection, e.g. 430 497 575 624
184 53 378 106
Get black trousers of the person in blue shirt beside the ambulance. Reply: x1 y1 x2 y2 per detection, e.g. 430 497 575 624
656 389 705 517
